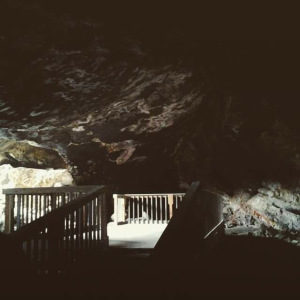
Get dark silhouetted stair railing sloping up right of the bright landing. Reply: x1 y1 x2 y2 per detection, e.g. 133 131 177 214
152 182 224 265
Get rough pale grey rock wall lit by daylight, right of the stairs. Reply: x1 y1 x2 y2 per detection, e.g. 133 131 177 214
224 183 300 246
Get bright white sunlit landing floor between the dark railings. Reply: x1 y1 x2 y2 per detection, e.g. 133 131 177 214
107 222 167 249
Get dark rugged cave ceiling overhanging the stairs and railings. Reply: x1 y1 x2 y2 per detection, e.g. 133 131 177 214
0 0 300 192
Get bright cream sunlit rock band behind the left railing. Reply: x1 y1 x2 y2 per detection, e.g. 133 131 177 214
0 164 73 229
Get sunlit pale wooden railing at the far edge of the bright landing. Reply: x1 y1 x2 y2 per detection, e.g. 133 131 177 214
113 193 184 224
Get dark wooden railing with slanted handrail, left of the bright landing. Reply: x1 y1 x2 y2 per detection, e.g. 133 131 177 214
3 186 111 271
